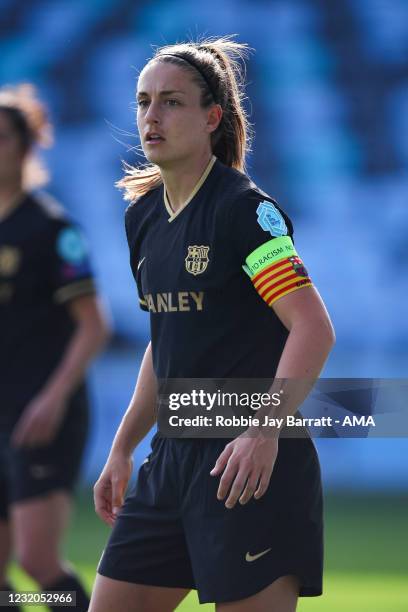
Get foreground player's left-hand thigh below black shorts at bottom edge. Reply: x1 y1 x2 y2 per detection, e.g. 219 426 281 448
88 574 189 612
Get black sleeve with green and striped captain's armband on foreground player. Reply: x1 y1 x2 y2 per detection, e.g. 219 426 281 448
229 194 312 306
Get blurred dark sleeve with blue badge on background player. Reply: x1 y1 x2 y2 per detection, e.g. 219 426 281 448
50 220 95 304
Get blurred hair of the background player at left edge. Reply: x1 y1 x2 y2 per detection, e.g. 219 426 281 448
0 83 53 190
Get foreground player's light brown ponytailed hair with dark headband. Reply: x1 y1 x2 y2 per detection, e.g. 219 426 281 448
116 36 251 202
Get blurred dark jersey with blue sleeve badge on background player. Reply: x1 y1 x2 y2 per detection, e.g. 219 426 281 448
0 196 94 426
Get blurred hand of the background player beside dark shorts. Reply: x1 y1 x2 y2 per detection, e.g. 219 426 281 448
11 392 65 447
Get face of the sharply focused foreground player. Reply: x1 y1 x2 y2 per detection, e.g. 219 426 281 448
137 62 218 169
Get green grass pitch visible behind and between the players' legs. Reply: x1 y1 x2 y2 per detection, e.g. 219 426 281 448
7 492 408 612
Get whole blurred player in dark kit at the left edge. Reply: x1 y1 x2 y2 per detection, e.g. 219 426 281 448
0 85 107 611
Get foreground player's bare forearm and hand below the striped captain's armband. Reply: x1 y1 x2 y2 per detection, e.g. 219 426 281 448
211 287 334 508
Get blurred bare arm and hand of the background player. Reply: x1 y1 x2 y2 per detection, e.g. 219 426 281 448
13 295 108 446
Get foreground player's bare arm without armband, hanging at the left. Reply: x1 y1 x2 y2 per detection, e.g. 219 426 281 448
94 342 157 525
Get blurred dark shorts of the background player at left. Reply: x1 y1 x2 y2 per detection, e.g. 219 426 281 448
0 386 89 520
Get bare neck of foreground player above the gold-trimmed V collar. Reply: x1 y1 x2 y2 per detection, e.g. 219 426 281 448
161 151 212 212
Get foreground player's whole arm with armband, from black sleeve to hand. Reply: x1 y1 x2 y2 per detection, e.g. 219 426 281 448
211 199 334 508
